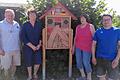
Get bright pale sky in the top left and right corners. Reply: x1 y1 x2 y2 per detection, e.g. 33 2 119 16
0 0 120 15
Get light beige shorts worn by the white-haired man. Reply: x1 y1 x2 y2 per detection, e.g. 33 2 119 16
1 51 21 70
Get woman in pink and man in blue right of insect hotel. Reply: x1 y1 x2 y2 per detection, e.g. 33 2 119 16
73 14 120 80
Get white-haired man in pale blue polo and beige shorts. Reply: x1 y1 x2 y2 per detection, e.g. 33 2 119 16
0 9 20 80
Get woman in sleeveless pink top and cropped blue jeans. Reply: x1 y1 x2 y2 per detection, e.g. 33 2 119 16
73 14 95 80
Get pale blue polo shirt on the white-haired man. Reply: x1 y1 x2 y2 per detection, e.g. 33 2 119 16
0 19 20 53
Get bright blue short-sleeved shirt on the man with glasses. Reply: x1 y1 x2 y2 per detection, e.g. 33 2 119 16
93 27 120 60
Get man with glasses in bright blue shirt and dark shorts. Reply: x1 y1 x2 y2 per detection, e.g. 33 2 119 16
92 14 120 80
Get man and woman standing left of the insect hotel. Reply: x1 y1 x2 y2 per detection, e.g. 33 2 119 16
0 9 42 80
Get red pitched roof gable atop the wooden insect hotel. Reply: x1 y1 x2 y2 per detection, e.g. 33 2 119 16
40 1 77 20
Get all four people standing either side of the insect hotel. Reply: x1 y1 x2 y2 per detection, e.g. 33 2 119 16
0 9 120 80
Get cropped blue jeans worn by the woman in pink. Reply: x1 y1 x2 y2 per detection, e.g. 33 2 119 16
76 48 92 73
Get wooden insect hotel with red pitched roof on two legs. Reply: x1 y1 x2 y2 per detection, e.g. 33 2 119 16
40 2 77 80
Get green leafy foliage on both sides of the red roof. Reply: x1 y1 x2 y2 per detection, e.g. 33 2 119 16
19 0 118 28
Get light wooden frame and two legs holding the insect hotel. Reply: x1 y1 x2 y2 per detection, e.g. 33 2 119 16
42 15 73 80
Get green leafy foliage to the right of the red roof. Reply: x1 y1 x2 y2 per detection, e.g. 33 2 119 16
60 0 112 28
